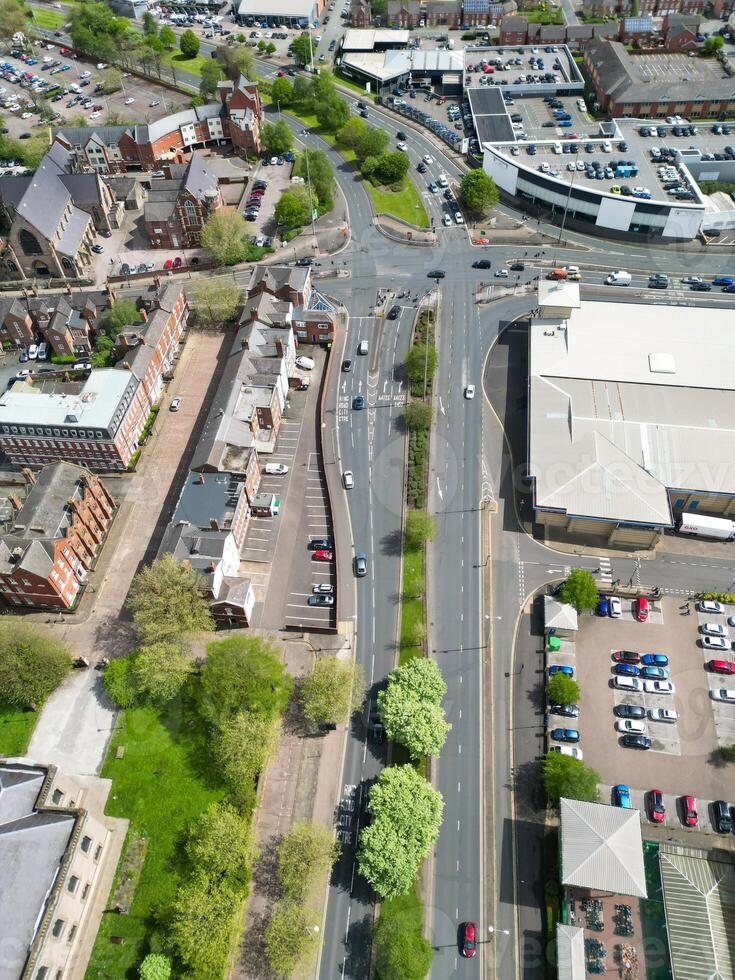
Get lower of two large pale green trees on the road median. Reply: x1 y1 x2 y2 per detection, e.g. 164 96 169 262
357 766 444 899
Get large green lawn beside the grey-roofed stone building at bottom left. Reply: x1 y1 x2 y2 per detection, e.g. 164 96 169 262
87 699 224 980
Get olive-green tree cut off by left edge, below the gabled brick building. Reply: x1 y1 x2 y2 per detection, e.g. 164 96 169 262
0 620 71 708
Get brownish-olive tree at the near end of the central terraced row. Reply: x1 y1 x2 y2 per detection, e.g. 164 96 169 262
127 555 213 645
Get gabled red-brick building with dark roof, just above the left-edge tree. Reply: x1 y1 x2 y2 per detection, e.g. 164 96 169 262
0 462 115 609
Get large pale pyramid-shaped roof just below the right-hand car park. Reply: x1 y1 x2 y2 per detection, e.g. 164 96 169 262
560 798 648 898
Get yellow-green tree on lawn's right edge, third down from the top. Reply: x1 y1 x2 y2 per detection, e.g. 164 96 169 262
186 802 256 889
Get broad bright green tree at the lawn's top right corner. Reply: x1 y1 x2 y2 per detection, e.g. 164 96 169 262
201 636 293 723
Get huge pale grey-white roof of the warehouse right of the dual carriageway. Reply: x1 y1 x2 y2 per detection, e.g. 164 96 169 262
529 301 735 526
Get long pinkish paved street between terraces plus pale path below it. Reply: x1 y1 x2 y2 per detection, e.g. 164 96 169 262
28 333 231 775
